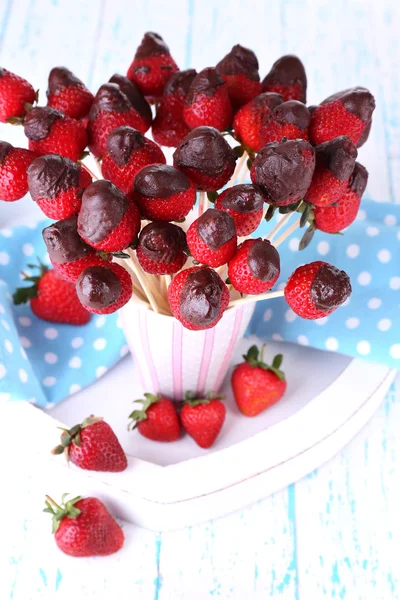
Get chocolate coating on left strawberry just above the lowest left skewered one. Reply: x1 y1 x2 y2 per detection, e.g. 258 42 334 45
42 215 93 265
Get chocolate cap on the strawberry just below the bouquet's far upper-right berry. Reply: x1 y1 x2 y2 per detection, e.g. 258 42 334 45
315 135 357 181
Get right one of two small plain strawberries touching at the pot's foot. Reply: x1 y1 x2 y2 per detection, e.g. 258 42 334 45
180 394 226 448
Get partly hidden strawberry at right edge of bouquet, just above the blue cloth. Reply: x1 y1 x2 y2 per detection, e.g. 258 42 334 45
314 162 368 233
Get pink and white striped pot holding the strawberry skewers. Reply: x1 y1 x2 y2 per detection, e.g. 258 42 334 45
120 302 256 400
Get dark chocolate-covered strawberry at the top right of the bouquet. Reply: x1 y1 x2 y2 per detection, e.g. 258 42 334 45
262 54 307 102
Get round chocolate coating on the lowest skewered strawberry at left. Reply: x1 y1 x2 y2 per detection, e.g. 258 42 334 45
76 267 122 309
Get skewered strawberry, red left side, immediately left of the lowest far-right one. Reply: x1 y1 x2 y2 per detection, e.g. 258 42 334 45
228 238 280 294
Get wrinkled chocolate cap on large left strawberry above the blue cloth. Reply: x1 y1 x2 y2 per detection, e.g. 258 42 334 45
27 154 80 202
